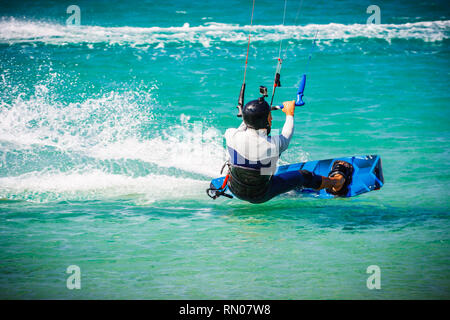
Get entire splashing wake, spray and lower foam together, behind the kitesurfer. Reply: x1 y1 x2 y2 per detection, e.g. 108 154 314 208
0 77 225 203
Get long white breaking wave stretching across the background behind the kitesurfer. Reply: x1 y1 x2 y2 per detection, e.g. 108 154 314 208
0 18 450 49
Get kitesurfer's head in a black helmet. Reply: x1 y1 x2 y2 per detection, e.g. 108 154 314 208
242 97 272 134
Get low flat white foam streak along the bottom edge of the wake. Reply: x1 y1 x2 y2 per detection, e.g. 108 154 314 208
0 169 205 203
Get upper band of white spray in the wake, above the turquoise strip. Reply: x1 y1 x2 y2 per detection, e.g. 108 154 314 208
0 90 225 177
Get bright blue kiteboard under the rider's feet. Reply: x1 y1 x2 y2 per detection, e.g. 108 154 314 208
210 155 384 199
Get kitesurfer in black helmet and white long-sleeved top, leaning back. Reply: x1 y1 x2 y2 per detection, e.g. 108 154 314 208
225 95 353 203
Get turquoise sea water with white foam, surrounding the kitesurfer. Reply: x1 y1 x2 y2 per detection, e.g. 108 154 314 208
0 0 450 299
